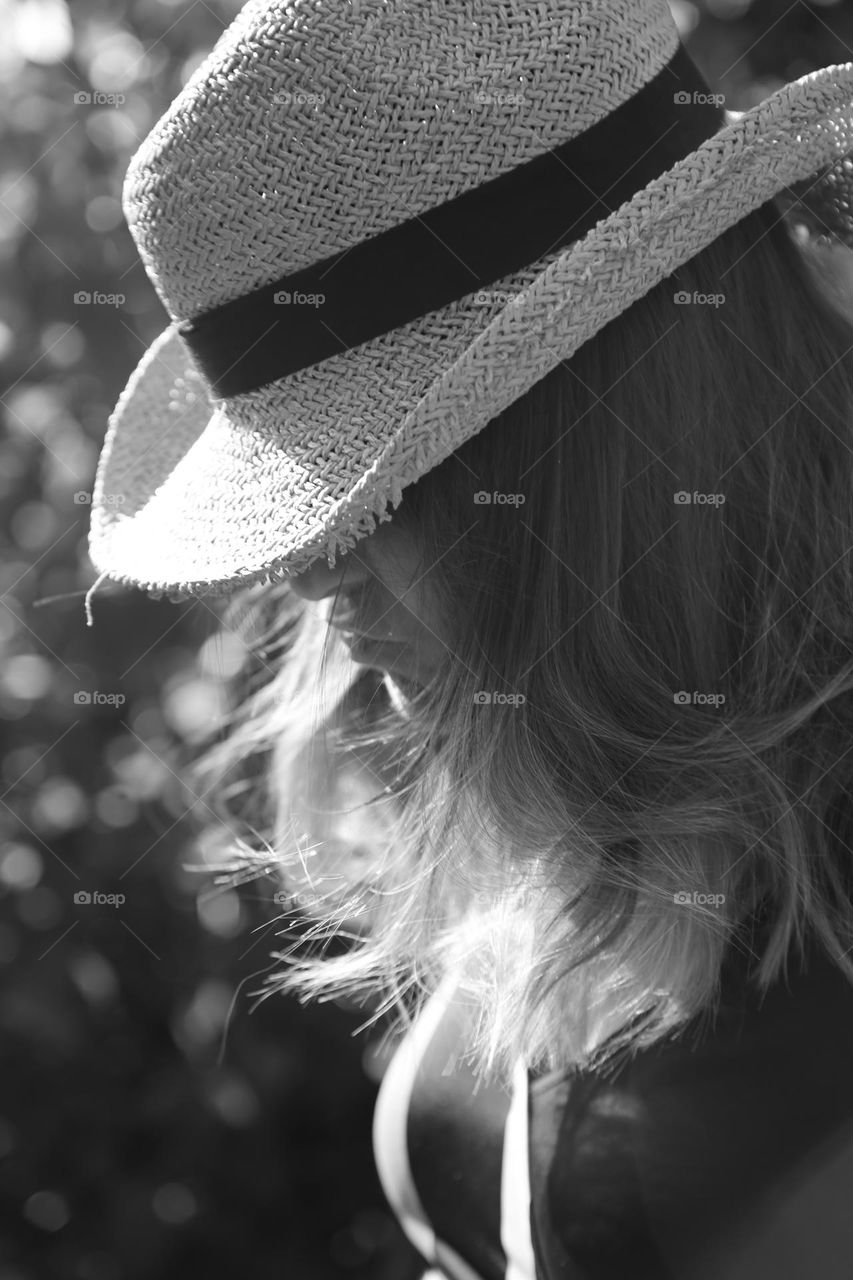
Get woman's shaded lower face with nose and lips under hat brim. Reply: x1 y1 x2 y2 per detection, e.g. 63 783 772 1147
285 521 447 692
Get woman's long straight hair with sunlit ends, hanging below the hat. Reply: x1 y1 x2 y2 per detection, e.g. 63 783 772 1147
192 202 853 1079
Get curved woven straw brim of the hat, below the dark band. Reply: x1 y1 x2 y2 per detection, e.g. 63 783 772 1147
90 63 853 598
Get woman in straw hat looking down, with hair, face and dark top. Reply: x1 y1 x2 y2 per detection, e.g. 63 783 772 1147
83 0 853 1280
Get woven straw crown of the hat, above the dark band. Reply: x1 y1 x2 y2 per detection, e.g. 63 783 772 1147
124 0 679 320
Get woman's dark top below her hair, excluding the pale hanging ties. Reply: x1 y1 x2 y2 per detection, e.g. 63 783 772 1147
397 921 853 1280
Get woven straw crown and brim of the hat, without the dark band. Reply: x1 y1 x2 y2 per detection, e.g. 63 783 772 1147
84 0 853 598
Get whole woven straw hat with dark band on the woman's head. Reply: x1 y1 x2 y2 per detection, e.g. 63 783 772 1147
86 0 853 625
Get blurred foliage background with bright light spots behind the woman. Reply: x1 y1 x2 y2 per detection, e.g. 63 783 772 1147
0 0 853 1280
